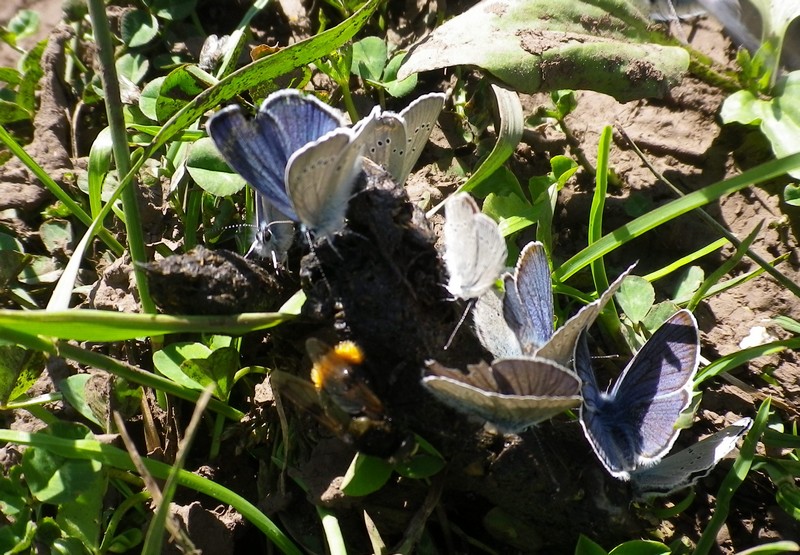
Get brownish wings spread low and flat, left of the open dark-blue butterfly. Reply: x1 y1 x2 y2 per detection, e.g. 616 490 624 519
422 358 580 433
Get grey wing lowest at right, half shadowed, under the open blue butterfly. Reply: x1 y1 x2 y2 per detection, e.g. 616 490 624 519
631 418 753 499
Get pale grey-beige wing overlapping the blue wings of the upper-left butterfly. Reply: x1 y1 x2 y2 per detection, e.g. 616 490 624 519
286 128 361 236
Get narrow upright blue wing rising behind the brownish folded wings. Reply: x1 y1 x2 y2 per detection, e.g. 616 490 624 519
503 241 554 354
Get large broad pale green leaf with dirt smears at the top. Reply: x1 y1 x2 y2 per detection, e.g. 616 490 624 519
398 0 689 102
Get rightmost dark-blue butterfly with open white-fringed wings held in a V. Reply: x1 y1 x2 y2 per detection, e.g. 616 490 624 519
575 310 700 480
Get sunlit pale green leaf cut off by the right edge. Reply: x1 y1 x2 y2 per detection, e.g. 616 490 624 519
720 71 800 178
